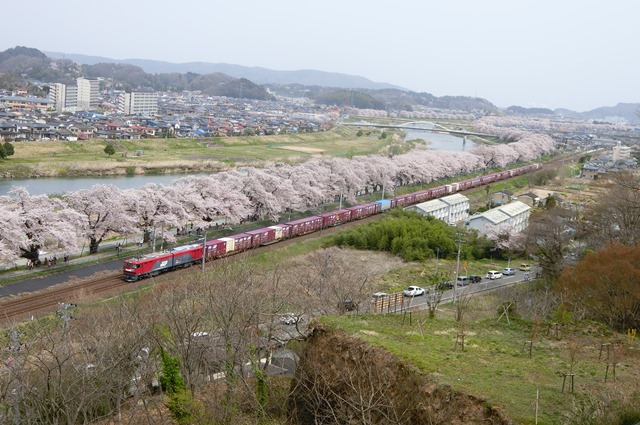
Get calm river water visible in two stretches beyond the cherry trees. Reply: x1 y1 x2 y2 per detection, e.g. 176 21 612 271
0 123 476 196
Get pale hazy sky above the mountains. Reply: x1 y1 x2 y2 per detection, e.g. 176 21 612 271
0 0 640 111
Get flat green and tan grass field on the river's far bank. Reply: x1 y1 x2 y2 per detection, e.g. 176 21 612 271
0 127 399 178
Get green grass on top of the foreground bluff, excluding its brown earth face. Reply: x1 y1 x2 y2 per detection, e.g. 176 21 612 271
323 304 640 424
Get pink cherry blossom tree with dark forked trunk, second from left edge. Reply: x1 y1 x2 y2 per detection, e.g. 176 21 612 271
63 184 136 254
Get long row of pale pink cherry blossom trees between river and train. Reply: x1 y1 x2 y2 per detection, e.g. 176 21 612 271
0 134 553 261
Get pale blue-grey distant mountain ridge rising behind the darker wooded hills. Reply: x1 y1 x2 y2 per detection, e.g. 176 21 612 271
45 52 403 90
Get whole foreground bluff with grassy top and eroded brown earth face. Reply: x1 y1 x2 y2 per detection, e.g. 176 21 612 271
294 300 640 424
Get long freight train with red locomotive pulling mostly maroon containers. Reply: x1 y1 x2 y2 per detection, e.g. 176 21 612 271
122 164 540 282
